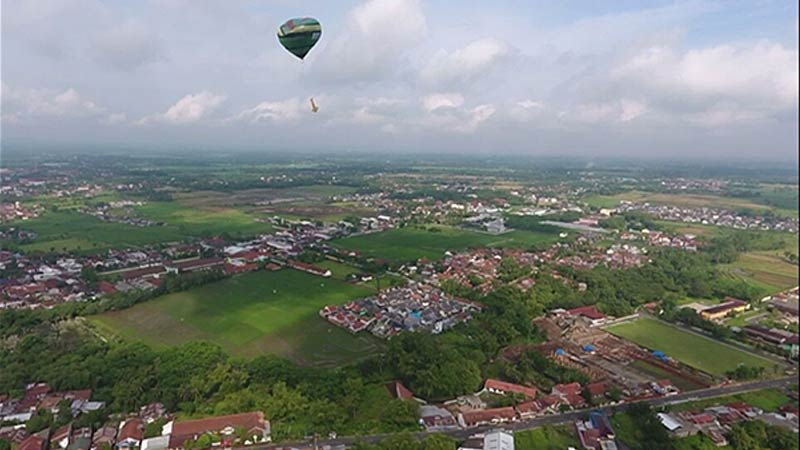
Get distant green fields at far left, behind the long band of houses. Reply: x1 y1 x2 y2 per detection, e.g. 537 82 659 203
12 202 272 252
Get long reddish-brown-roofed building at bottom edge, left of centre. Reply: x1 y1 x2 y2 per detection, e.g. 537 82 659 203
162 411 270 448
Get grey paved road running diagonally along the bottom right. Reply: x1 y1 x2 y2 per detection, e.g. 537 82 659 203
256 376 797 450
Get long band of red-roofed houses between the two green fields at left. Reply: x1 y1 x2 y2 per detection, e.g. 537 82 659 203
0 219 356 308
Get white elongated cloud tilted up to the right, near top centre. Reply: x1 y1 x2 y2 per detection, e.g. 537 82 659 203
420 38 511 84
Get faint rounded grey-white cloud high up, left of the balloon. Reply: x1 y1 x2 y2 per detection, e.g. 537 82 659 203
90 21 164 70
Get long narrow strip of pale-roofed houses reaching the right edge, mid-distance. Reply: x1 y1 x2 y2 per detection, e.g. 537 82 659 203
616 201 800 233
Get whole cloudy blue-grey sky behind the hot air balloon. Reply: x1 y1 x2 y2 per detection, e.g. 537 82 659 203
0 0 798 162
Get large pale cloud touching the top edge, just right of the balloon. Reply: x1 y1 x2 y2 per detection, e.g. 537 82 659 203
312 0 427 83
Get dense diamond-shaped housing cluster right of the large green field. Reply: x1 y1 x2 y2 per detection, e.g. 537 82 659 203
319 282 480 339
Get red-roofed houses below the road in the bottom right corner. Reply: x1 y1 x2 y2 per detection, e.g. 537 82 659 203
658 402 800 447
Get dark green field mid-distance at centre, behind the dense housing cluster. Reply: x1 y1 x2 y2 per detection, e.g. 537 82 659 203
331 226 555 261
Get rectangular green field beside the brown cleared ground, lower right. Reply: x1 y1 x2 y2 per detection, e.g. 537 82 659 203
607 318 775 375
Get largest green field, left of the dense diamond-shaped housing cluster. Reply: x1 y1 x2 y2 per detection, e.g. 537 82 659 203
89 269 381 366
